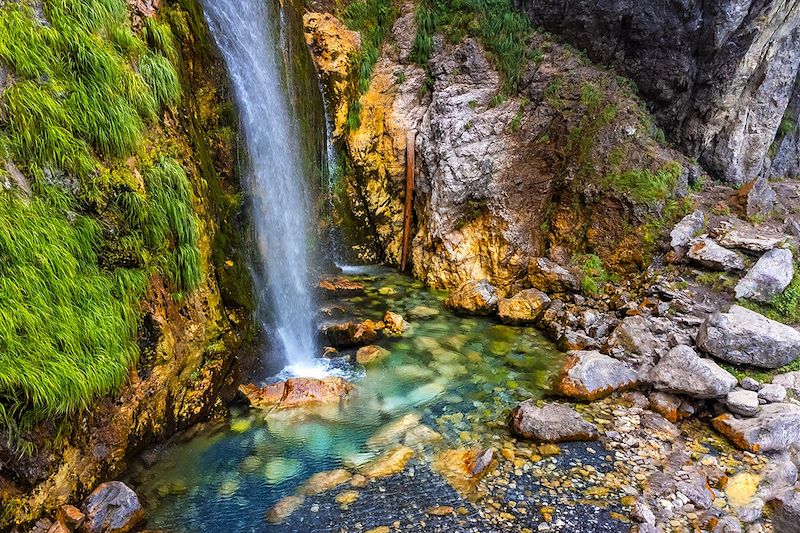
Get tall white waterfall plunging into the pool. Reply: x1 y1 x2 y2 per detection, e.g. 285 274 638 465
203 0 318 372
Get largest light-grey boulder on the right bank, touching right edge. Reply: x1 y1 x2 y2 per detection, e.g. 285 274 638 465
696 305 800 368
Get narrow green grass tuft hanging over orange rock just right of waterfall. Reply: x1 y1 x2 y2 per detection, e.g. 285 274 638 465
342 0 396 97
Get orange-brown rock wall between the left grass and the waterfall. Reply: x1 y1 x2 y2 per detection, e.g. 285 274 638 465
0 1 252 531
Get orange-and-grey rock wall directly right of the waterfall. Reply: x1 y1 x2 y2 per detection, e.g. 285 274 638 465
306 4 692 292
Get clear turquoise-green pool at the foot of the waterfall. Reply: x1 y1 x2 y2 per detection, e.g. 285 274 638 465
129 268 559 532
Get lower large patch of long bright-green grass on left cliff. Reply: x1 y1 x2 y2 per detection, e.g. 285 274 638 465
0 194 141 437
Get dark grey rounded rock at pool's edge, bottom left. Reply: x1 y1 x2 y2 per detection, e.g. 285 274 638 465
81 481 145 533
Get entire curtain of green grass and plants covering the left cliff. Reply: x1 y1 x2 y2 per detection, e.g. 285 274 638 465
0 0 202 442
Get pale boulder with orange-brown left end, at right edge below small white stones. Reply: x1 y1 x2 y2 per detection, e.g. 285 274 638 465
712 403 800 452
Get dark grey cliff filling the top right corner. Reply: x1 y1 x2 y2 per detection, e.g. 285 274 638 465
519 0 800 184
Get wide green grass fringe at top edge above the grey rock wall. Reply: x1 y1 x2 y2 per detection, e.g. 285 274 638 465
411 0 542 94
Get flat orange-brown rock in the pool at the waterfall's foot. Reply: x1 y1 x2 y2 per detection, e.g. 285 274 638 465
239 376 353 408
